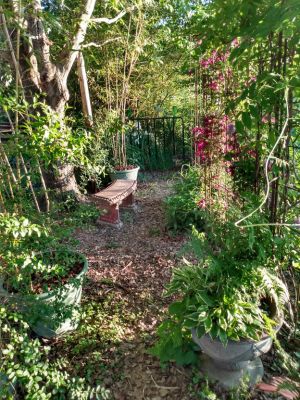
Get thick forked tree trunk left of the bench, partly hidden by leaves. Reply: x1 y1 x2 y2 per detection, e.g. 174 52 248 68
0 0 127 198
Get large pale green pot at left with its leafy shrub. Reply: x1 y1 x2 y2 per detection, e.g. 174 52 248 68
0 214 88 338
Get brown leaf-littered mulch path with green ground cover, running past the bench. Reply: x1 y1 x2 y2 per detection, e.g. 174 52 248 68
55 177 296 400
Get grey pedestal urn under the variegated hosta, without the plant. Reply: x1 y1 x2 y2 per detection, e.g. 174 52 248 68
192 323 282 388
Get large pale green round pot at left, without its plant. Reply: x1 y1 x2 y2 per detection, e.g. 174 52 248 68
0 255 88 339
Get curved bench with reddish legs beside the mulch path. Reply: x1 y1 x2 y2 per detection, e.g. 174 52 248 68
92 179 137 228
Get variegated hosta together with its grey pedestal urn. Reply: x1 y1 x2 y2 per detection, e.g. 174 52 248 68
168 260 286 387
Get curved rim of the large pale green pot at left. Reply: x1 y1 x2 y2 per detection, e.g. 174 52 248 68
0 250 88 300
